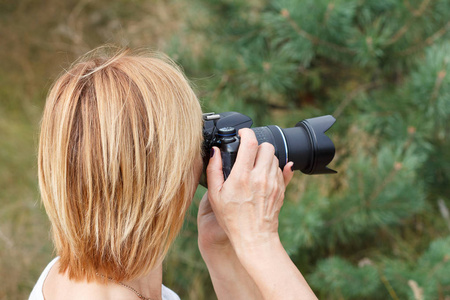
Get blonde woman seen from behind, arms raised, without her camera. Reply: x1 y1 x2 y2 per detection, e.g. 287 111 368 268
30 51 315 300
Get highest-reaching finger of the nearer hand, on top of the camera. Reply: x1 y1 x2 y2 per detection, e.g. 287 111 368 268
232 128 258 172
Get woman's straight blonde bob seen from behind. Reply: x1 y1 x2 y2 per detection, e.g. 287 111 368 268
39 51 202 281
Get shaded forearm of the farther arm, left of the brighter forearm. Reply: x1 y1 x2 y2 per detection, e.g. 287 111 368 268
200 245 263 300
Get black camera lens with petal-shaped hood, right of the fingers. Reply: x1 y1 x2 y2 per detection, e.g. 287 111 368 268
252 115 336 174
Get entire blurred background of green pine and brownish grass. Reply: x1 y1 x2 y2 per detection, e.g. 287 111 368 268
0 0 450 300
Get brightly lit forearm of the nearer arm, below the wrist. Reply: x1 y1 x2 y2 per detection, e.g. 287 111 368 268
236 237 317 300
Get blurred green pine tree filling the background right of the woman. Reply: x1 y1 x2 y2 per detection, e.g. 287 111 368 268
165 0 450 299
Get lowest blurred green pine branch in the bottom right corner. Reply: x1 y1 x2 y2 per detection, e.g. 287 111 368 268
309 236 450 300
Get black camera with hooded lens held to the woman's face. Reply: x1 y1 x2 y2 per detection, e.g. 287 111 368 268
201 112 337 186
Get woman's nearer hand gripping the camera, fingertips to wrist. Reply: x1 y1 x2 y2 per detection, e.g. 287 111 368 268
206 128 293 255
